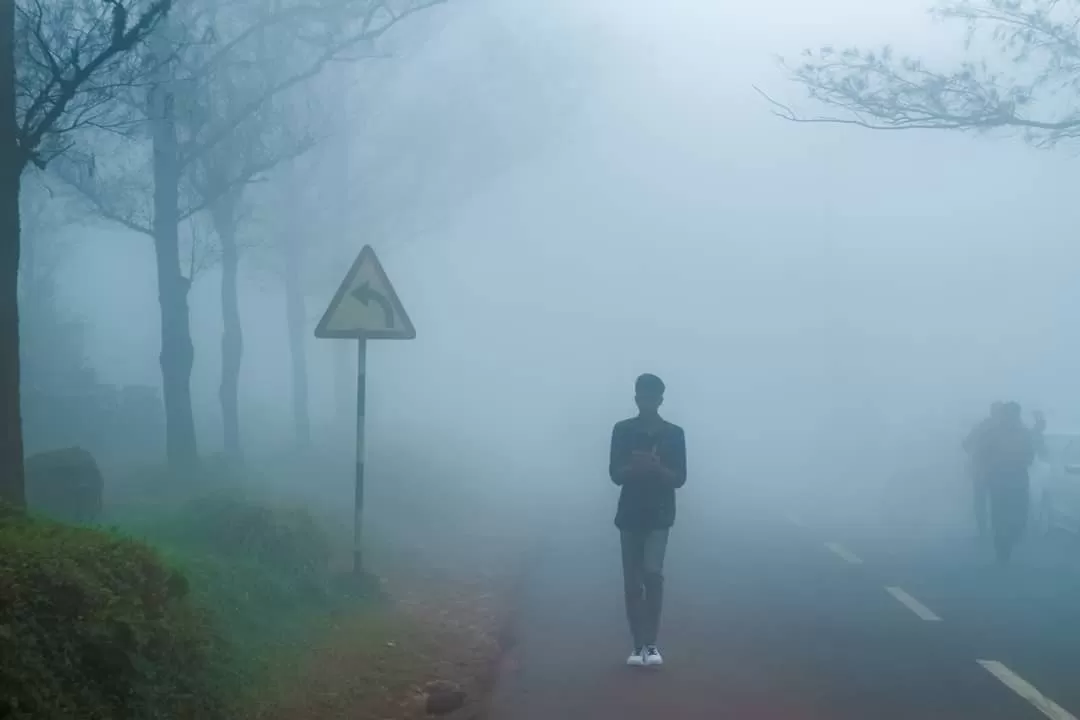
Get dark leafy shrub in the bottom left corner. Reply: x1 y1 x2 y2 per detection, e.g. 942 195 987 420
0 508 225 720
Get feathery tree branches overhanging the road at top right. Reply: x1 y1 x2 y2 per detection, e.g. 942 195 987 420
762 0 1080 147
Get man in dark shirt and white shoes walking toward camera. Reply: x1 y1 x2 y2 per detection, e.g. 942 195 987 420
608 375 686 666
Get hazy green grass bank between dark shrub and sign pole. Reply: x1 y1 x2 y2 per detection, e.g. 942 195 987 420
110 492 367 706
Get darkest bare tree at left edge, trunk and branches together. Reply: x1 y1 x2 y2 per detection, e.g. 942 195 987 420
0 0 172 506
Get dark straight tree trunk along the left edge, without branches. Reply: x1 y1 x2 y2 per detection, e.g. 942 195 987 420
0 0 26 507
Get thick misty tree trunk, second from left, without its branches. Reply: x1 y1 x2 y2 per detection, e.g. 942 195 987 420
151 84 199 471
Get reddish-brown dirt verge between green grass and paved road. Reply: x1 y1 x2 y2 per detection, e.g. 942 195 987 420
252 533 531 720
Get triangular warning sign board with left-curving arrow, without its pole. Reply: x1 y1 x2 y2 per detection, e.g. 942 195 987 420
315 245 416 340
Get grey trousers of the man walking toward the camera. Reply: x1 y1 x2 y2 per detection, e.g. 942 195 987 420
622 530 669 648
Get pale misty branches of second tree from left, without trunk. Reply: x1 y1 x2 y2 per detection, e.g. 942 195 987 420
59 0 446 248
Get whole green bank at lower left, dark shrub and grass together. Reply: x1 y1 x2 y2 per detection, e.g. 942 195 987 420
0 481 377 720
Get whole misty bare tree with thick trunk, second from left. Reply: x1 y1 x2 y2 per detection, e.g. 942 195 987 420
60 0 445 470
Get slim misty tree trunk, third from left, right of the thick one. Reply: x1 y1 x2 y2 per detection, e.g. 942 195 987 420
213 193 244 461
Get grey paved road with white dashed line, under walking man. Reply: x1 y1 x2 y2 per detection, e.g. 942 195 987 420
494 498 1080 720
